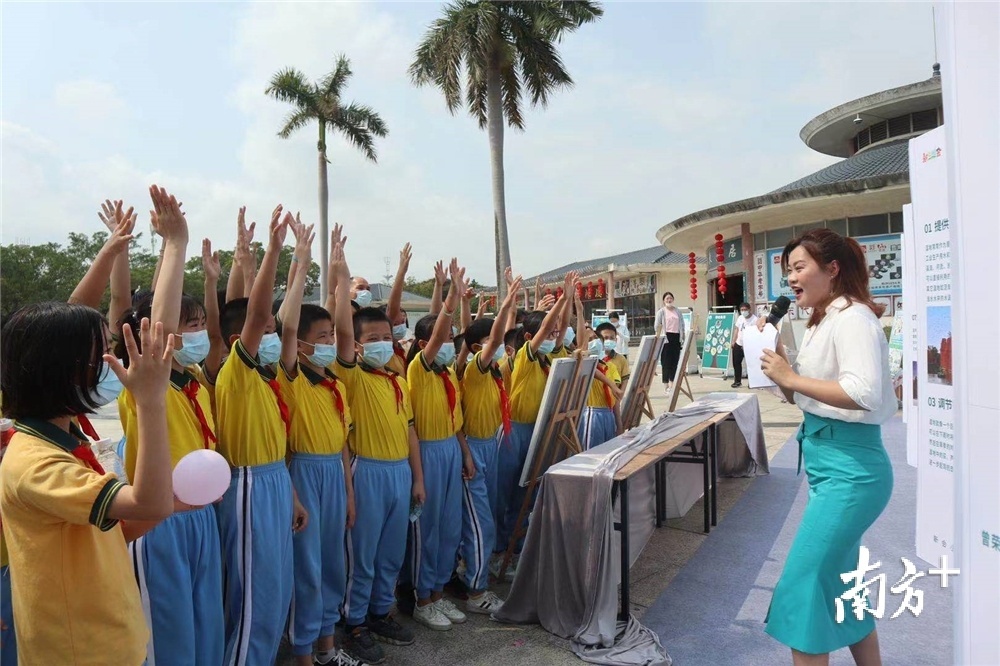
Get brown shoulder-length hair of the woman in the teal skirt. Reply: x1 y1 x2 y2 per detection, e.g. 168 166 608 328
781 229 885 328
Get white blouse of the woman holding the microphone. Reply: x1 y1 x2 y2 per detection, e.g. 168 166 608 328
793 296 897 425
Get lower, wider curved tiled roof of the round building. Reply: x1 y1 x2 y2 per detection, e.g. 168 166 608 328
656 139 910 252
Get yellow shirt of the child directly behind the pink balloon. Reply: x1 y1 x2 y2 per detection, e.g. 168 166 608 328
118 369 215 481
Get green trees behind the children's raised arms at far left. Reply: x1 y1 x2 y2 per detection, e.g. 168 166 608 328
0 231 319 318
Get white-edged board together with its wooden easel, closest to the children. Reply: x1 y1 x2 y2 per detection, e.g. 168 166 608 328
499 356 598 580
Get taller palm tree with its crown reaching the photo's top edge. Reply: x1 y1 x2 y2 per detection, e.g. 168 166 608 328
409 0 604 295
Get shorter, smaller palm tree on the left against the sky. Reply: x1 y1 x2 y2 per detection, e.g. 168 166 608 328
265 55 389 303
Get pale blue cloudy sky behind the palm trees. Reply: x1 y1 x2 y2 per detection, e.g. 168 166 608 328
0 2 934 283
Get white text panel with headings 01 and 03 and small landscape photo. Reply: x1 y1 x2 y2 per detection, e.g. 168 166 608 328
904 127 955 564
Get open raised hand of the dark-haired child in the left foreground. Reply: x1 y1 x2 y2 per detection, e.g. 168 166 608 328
104 318 174 406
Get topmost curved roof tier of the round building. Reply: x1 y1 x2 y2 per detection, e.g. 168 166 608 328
799 75 942 157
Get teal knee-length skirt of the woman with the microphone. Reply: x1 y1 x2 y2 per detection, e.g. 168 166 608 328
764 414 892 654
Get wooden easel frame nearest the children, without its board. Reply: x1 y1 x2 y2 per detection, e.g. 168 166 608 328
499 357 593 580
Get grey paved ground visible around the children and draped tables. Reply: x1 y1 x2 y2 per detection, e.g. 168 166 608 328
93 364 801 666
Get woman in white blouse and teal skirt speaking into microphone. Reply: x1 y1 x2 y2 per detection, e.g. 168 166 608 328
758 229 896 666
